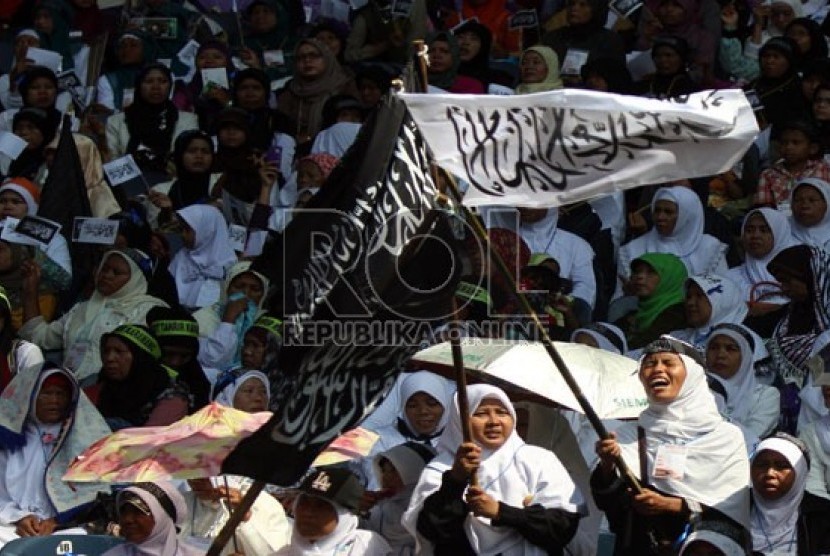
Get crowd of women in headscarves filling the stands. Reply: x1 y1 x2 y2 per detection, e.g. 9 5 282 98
0 0 830 556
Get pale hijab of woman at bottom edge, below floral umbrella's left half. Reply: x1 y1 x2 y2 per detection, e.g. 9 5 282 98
105 481 198 556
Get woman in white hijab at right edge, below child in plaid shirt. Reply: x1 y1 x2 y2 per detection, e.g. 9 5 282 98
790 178 830 251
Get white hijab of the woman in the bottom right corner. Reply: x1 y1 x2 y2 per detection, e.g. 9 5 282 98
752 437 809 554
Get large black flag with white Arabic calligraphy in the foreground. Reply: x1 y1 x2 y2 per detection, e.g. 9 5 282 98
223 93 460 485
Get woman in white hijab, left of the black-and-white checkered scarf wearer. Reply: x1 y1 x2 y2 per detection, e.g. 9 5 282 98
726 207 797 337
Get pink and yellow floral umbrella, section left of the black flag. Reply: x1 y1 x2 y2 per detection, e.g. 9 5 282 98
63 403 271 483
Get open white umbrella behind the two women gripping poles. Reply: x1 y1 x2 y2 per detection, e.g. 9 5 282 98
412 338 648 419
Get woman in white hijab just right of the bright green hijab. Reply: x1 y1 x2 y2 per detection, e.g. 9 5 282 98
669 274 747 349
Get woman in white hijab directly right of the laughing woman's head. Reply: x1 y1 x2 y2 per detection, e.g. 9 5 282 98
705 324 781 452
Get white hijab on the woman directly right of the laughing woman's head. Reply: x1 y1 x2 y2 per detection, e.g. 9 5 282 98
704 324 759 424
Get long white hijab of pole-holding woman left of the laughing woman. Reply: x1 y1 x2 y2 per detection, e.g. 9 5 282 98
402 384 583 556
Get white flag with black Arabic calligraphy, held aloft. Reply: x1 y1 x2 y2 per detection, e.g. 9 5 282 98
400 89 758 207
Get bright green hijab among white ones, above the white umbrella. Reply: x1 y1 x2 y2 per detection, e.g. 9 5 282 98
631 253 688 330
